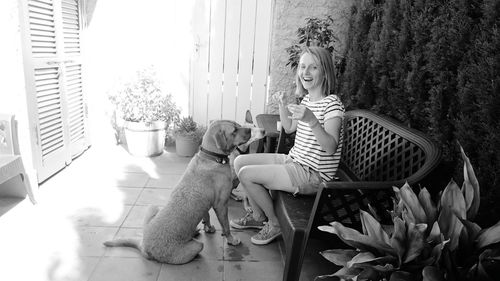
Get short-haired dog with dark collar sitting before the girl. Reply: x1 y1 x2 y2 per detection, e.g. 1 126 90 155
104 120 264 264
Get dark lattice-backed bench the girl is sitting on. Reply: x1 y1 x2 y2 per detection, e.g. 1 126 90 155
272 110 441 281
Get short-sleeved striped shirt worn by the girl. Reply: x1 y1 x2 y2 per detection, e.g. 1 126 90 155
289 95 345 181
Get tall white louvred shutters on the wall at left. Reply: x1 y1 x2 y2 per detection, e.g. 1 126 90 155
20 0 89 182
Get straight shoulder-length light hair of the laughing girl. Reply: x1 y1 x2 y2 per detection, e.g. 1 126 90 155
295 47 336 97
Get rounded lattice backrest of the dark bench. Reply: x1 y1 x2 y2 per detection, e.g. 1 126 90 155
341 110 440 183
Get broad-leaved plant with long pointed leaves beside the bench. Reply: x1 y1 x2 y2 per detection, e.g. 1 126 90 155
317 144 500 281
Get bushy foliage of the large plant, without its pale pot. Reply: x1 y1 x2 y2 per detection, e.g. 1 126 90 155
109 68 180 126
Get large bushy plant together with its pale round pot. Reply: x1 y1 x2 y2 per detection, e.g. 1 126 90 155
109 68 180 157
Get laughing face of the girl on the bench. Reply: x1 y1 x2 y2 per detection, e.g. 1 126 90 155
297 53 325 93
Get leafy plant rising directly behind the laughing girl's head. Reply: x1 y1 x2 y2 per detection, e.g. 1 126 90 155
286 16 338 71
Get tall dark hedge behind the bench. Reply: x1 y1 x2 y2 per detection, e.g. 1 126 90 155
339 0 500 225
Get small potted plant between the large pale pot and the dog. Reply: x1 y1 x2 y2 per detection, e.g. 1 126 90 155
174 116 207 157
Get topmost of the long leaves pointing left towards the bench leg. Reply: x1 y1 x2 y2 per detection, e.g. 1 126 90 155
318 221 393 253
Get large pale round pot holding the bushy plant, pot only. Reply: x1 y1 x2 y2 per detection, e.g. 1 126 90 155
125 121 167 157
